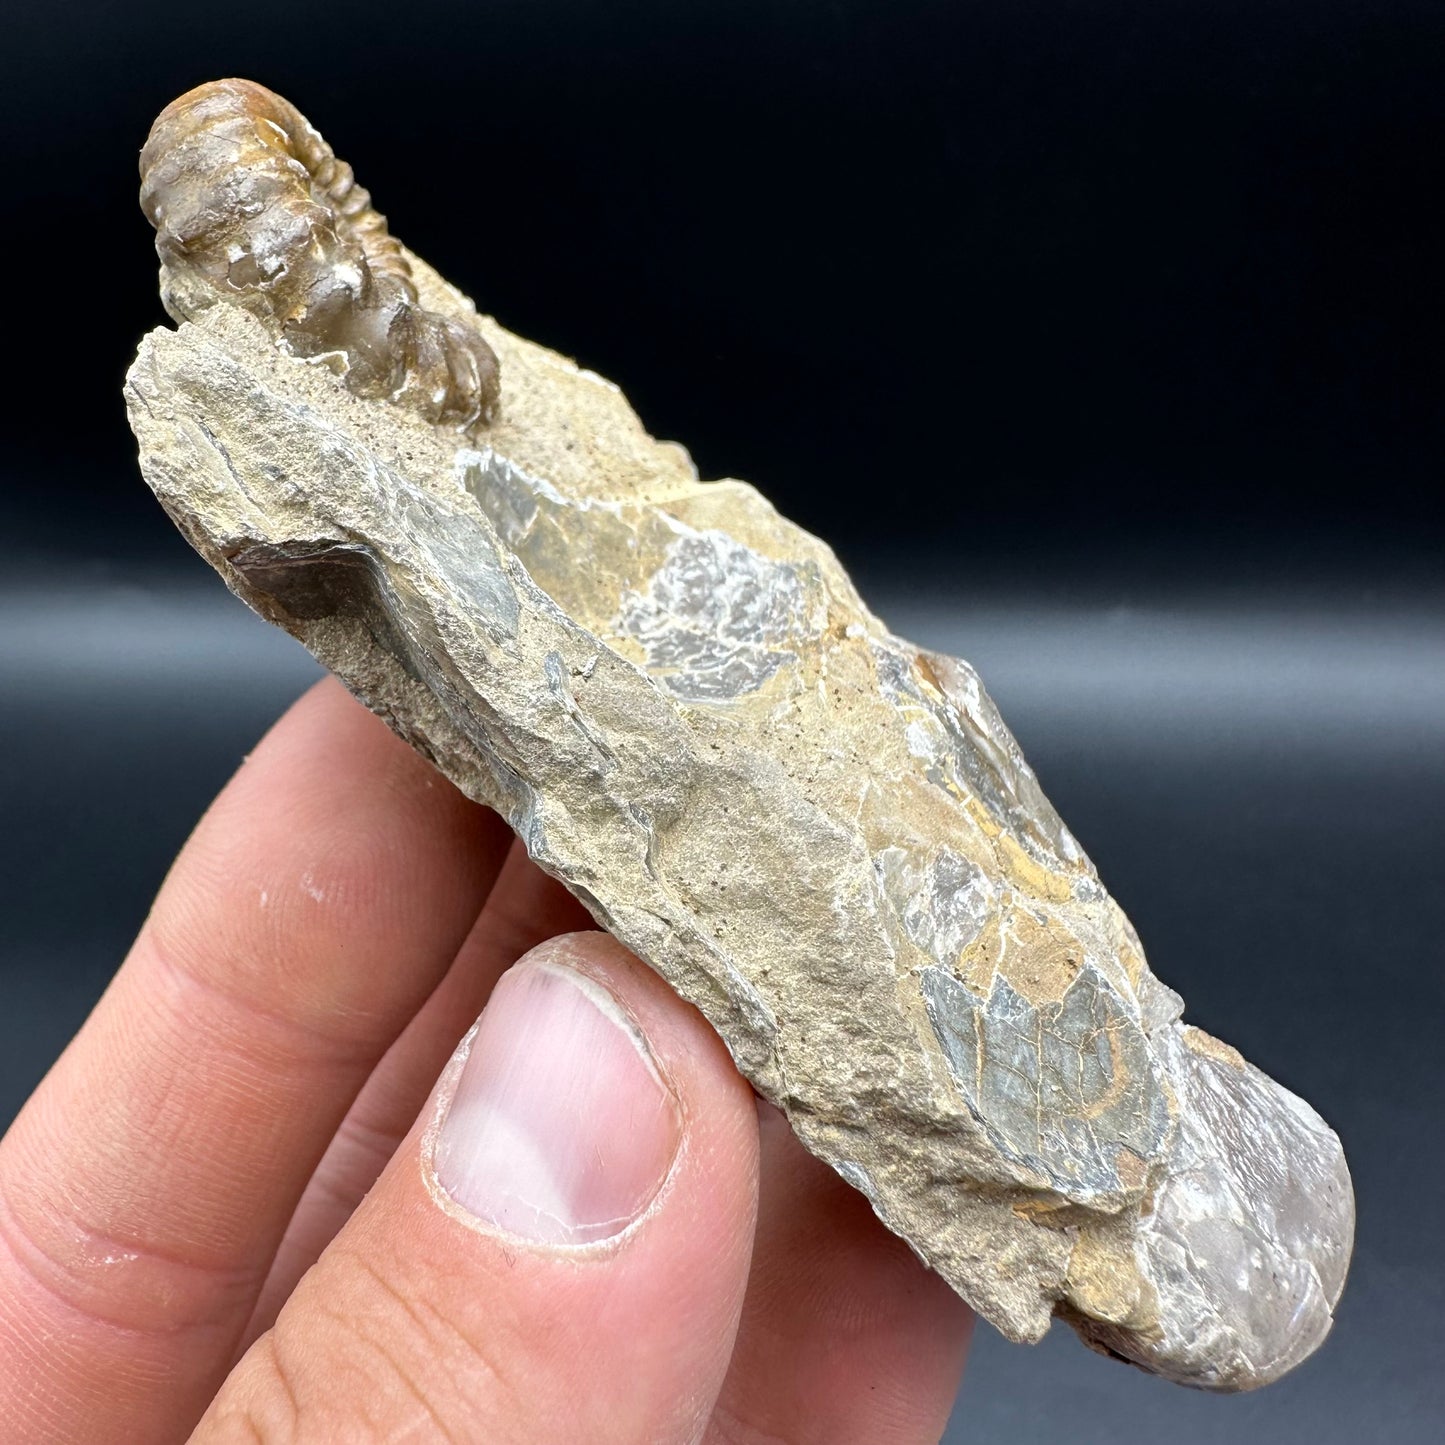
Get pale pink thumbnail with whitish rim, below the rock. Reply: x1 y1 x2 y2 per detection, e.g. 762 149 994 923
432 961 682 1244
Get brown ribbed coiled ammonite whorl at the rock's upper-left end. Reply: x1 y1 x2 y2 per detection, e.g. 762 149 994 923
140 79 499 428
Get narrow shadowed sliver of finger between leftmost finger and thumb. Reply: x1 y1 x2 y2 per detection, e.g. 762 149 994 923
238 840 591 1353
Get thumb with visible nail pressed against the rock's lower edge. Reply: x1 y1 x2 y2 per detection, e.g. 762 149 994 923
195 933 757 1445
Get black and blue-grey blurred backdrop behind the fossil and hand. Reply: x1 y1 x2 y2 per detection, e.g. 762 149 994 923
0 0 1445 1442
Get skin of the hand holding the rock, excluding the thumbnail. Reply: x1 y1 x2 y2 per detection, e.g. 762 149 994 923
0 681 971 1445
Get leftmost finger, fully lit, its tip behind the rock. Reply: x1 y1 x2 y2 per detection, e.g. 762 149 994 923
0 682 507 1442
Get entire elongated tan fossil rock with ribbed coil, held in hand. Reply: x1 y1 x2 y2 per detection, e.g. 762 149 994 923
127 82 1353 1389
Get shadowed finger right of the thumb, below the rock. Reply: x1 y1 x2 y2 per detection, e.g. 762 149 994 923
709 1104 972 1445
